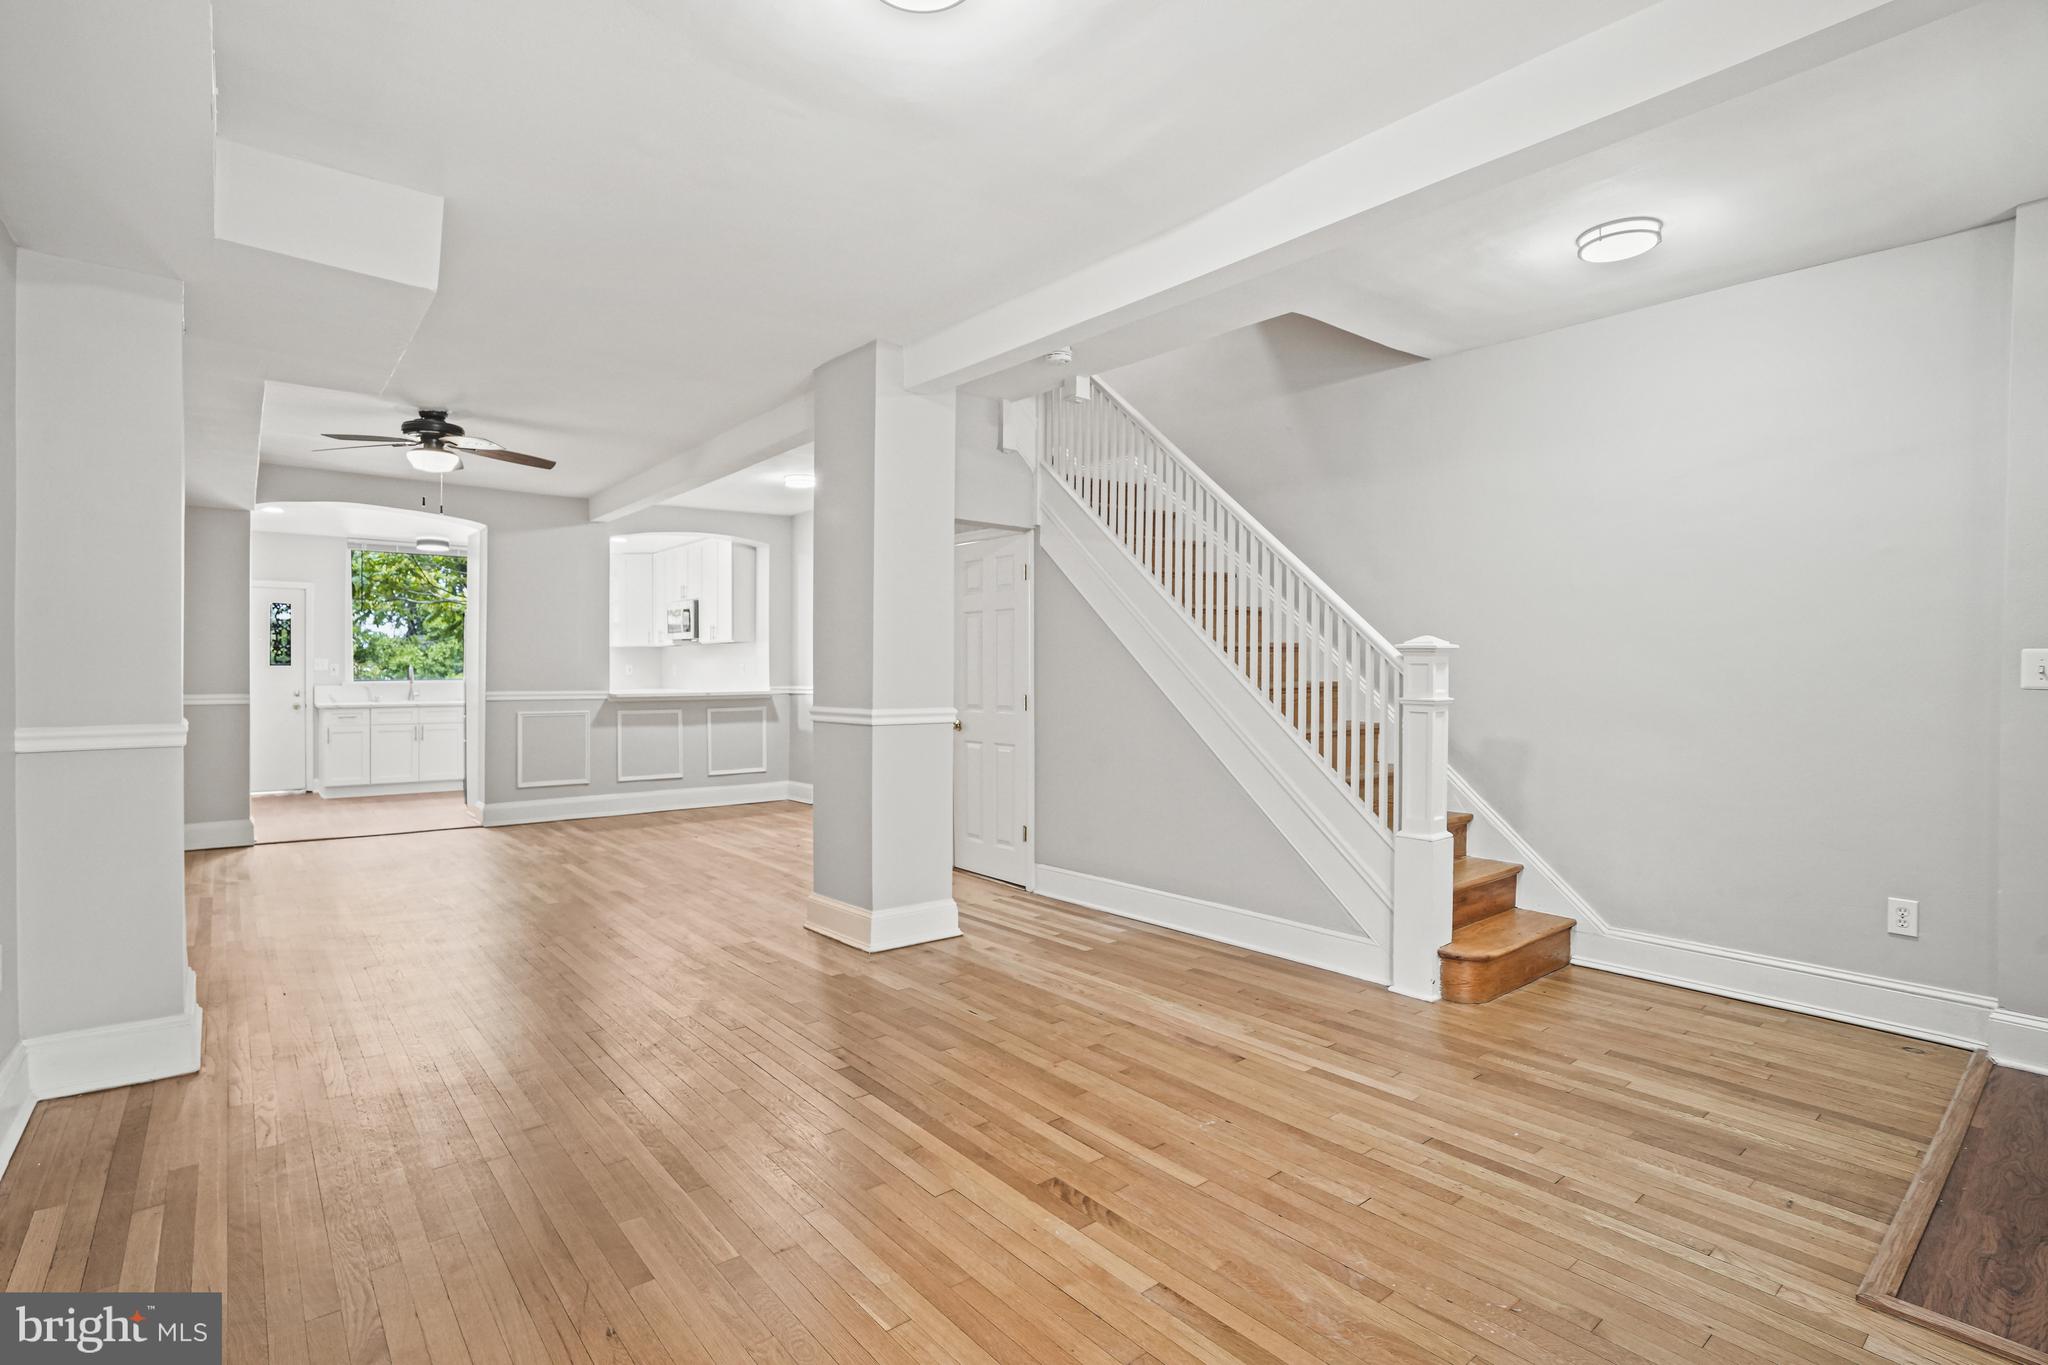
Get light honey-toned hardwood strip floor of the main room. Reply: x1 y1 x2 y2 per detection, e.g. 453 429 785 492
0 806 2015 1365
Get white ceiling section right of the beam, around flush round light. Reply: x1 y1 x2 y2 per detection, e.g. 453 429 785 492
1302 0 2048 354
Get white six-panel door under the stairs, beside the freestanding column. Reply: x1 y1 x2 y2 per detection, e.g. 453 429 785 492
952 532 1032 886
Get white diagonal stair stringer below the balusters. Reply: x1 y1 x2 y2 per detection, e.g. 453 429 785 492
1038 477 1393 982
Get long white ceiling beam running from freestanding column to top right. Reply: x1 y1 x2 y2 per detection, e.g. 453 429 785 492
903 0 1974 389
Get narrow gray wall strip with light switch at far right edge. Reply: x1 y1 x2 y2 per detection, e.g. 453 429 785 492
1995 201 2048 1015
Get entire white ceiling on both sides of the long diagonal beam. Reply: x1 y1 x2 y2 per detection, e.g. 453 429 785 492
0 0 2048 510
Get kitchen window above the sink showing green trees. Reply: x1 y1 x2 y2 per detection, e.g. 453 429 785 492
348 548 469 681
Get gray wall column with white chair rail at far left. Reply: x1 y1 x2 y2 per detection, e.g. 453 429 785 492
14 252 199 1099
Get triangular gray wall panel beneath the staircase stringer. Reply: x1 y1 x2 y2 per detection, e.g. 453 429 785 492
1034 555 1358 931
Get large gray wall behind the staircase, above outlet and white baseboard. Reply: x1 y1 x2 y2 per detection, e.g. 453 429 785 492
1110 225 2015 995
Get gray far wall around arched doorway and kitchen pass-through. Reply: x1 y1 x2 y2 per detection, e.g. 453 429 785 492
256 465 795 806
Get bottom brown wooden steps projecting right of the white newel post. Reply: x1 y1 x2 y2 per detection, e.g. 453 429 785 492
1436 810 1577 1005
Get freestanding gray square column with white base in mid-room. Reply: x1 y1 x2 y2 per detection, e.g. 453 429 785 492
805 342 961 952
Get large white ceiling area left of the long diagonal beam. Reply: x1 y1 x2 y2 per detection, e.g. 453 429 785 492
0 0 1647 501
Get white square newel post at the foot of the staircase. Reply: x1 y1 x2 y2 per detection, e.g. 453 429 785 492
1391 634 1458 1001
